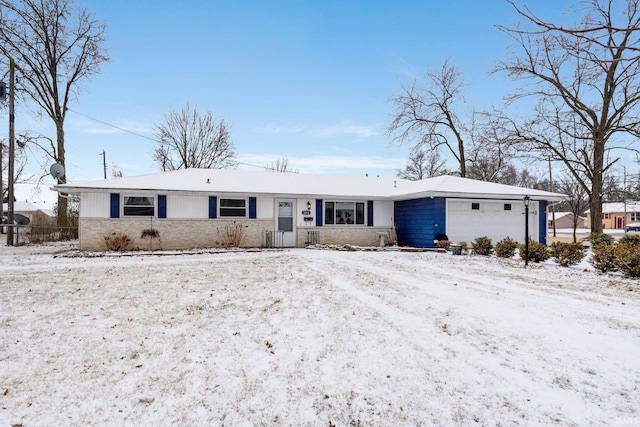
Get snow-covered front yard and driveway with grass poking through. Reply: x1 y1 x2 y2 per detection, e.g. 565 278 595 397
0 242 640 427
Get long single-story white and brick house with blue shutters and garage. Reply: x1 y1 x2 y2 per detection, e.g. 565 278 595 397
54 169 563 250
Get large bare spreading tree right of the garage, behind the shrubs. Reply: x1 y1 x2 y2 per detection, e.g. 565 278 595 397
495 0 640 232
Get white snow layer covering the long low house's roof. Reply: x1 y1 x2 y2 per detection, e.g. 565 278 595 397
53 168 564 200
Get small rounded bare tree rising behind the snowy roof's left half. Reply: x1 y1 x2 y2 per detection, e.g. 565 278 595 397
153 103 235 171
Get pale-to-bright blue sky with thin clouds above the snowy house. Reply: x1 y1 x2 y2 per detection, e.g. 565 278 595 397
8 0 562 207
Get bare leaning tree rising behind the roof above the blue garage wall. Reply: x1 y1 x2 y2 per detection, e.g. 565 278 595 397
388 61 467 177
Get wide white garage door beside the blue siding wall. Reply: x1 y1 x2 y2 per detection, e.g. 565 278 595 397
446 199 539 243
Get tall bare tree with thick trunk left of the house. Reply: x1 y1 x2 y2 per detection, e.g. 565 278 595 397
0 0 108 225
